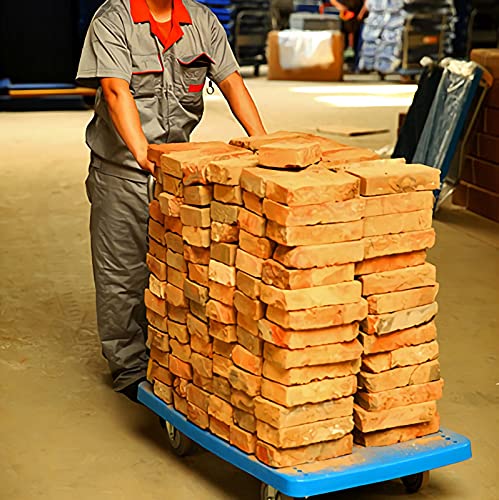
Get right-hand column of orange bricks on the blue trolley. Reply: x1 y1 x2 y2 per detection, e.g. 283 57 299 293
347 160 443 446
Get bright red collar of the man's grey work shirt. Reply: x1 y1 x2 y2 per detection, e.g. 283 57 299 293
130 0 192 50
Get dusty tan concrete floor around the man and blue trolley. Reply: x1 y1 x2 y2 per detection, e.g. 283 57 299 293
0 75 499 500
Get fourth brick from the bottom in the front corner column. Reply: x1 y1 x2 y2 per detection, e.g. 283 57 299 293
262 375 357 408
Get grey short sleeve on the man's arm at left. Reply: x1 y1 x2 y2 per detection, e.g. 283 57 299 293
76 17 132 88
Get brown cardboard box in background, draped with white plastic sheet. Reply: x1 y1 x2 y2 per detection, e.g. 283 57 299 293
267 31 344 82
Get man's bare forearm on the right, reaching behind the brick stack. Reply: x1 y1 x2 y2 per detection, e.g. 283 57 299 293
218 72 267 135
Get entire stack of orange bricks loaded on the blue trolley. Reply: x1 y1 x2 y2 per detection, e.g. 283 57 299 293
145 132 441 467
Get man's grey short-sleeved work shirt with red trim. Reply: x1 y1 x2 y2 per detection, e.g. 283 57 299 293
77 0 239 179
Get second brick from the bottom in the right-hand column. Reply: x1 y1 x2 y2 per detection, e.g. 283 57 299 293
354 401 437 432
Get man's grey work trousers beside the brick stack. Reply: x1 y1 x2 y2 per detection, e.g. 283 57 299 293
86 166 149 391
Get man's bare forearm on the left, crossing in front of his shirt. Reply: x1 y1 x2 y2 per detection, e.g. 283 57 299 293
101 78 154 173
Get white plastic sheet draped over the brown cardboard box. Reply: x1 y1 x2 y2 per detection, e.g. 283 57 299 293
279 30 334 69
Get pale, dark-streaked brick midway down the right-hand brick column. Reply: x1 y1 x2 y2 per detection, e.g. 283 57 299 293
361 302 438 335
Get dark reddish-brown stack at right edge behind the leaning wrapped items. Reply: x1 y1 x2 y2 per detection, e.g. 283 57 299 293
453 49 499 222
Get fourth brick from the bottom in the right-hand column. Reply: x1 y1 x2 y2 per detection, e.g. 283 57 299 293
359 360 440 392
